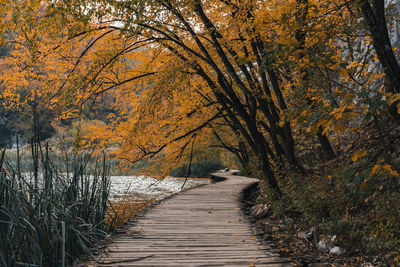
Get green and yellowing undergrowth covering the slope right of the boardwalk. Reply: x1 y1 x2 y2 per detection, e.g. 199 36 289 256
253 123 400 266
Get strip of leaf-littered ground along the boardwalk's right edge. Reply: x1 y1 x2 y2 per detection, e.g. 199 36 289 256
242 183 396 267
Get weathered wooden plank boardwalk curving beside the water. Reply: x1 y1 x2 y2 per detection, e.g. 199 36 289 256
90 173 290 266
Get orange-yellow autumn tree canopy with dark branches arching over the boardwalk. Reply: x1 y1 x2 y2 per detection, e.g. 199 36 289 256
1 0 400 192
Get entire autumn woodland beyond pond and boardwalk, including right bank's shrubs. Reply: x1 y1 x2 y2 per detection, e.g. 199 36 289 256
0 0 400 266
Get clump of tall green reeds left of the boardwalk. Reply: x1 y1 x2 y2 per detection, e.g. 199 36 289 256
0 142 110 267
